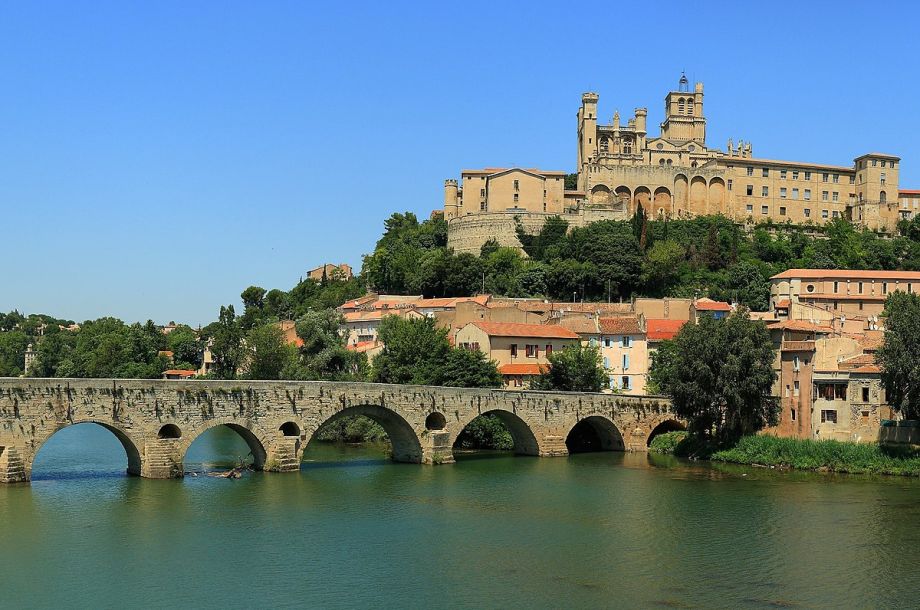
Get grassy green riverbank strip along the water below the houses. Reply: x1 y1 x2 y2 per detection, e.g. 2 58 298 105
649 432 920 476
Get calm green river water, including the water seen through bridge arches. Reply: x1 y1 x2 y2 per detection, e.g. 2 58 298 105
0 425 920 608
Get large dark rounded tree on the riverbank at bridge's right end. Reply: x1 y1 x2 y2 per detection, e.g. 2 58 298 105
650 309 779 442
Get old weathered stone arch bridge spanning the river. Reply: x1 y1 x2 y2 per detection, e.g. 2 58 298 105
0 378 682 483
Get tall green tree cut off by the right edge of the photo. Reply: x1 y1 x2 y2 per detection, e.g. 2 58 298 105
875 291 920 419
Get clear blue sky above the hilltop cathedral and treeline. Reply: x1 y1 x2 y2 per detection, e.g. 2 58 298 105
0 1 920 324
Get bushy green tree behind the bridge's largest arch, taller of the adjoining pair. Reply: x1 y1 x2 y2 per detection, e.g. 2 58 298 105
373 316 450 385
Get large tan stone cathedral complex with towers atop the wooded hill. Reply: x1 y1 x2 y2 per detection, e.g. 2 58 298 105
444 75 915 251
